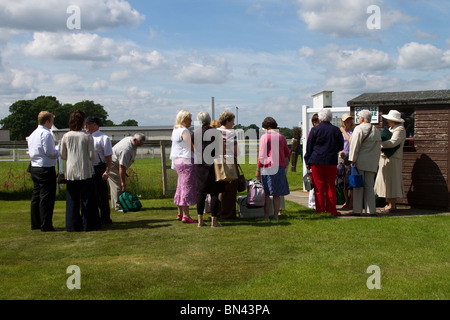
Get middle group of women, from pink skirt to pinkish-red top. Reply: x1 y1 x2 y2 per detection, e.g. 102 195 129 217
170 110 290 228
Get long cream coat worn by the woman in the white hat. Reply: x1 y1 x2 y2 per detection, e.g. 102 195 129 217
374 124 406 198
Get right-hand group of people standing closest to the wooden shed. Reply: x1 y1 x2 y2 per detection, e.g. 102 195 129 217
304 108 406 215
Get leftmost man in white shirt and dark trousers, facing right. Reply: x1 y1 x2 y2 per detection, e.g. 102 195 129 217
27 111 59 231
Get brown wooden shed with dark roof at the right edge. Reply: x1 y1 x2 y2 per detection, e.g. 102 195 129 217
347 90 450 209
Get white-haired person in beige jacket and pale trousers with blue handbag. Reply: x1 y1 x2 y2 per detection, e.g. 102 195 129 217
348 110 381 215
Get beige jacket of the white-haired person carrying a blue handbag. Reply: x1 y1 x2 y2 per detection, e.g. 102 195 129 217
349 123 381 172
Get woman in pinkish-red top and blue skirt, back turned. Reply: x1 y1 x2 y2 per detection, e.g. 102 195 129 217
255 117 290 220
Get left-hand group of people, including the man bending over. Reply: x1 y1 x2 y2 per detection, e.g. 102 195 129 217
27 110 145 232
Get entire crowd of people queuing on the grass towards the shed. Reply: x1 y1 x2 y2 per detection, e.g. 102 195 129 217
27 108 406 232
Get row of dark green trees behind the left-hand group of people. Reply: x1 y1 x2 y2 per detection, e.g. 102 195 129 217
0 96 138 141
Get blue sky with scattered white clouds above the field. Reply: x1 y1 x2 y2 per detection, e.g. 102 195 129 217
0 0 450 127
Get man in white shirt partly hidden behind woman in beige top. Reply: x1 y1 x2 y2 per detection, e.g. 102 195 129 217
86 117 112 224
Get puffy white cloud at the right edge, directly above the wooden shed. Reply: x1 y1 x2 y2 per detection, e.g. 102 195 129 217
398 42 450 70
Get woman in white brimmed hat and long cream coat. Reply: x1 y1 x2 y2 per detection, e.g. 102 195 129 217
374 110 406 213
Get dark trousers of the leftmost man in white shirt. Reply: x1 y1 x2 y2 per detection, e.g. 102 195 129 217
30 167 56 231
